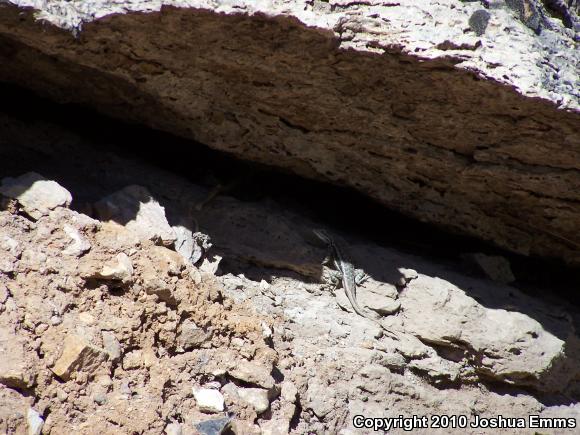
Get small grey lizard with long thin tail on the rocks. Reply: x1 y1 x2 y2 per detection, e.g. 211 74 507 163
313 229 398 339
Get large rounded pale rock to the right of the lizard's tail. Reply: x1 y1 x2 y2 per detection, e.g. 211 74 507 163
403 276 580 391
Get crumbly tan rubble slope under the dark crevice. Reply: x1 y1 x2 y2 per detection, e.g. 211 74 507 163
0 104 580 435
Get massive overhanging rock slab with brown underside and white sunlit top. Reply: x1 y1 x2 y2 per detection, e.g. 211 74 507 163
0 0 580 265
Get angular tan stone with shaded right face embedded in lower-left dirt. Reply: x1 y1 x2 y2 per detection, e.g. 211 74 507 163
52 335 107 381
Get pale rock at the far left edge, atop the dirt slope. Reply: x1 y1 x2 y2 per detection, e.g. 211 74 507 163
0 172 72 219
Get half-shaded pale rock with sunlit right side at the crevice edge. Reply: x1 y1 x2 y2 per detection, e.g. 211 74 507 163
95 185 175 245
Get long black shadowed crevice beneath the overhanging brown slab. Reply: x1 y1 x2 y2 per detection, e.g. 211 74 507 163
0 84 580 303
